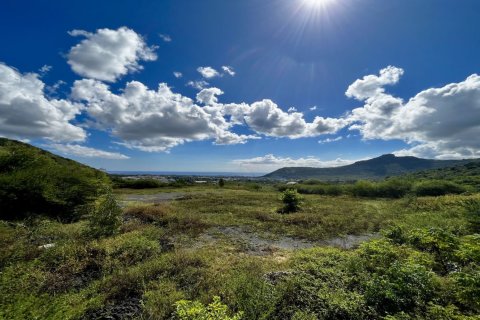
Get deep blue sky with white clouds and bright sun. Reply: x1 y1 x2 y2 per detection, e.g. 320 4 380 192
0 0 480 172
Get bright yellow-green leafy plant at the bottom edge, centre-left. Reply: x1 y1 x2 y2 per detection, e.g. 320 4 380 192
175 296 242 320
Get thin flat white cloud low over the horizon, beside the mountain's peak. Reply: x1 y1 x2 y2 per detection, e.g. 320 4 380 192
232 154 358 172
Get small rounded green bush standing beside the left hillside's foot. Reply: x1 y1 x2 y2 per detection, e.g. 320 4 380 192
87 191 122 238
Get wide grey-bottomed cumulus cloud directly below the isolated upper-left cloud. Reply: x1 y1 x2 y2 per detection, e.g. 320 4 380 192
72 79 254 151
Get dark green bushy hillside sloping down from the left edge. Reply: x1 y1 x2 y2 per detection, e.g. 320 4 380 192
0 138 110 220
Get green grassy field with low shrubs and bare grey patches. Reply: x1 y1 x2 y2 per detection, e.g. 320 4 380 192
0 184 480 320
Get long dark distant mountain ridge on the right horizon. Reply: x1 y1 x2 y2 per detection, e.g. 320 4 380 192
264 154 480 181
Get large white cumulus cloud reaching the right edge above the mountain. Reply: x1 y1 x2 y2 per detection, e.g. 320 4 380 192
346 67 480 158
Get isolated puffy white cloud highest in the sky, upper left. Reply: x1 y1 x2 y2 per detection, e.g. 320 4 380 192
68 27 157 82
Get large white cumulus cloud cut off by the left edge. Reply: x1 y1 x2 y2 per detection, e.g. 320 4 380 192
0 63 86 141
